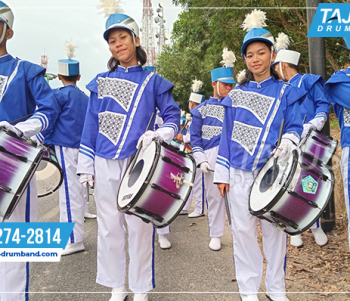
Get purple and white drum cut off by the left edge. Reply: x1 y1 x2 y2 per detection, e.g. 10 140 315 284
0 128 44 220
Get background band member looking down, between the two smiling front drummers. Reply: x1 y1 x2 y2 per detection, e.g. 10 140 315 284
191 48 236 251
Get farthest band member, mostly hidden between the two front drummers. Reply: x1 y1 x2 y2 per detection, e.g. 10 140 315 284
182 80 205 218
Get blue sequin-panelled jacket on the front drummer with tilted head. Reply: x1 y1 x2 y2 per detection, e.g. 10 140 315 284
78 66 180 175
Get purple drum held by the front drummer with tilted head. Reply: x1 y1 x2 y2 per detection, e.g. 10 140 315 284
117 141 196 228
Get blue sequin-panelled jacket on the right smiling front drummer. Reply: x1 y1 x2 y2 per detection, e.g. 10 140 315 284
214 77 306 183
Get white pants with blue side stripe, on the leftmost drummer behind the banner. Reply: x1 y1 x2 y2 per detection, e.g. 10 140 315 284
0 175 38 301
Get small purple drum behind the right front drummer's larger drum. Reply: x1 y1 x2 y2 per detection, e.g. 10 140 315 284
300 130 338 164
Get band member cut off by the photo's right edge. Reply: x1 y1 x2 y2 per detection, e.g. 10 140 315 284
325 37 350 250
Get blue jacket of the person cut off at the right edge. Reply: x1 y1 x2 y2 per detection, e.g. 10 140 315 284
325 68 350 147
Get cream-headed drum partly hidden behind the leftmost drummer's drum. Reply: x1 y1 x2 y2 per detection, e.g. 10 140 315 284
35 147 63 197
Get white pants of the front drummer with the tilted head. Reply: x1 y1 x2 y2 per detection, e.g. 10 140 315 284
95 156 155 292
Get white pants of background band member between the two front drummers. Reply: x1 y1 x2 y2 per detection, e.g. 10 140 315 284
204 146 225 238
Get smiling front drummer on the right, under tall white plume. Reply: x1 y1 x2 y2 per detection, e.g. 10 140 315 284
214 10 302 301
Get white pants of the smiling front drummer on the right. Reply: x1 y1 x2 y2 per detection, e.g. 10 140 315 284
228 168 287 296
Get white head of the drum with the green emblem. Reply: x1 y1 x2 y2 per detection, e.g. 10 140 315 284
249 151 298 215
